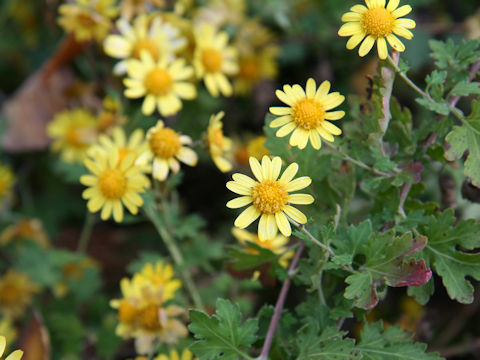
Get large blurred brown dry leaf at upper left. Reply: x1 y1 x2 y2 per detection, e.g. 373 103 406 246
2 37 86 152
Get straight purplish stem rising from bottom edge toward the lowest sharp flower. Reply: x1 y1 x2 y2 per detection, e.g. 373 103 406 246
258 241 305 360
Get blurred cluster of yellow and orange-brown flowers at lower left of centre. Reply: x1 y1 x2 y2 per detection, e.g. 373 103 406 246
110 262 188 354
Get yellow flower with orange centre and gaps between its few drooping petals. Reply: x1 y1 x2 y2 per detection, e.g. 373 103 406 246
147 120 198 181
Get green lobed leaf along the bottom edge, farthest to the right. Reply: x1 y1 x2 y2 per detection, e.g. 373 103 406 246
356 322 442 360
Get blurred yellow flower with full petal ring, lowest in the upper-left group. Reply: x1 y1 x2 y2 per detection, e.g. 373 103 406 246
123 50 197 116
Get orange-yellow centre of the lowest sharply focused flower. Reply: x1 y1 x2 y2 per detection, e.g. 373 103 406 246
252 180 288 214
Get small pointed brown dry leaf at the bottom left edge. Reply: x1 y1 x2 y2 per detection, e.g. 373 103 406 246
20 310 51 360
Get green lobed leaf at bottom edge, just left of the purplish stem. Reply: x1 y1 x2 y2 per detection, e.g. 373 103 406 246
188 299 258 360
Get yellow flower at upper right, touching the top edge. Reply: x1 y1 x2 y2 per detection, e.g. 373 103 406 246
338 0 415 60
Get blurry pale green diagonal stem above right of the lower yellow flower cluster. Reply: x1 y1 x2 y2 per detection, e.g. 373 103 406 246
144 206 203 310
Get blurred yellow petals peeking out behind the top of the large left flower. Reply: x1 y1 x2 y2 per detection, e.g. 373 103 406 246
88 127 151 172
